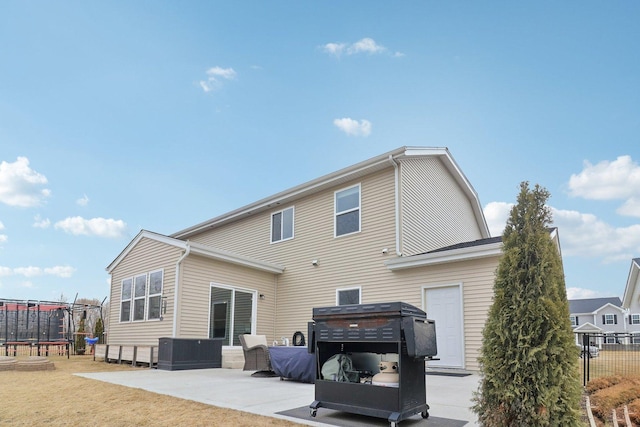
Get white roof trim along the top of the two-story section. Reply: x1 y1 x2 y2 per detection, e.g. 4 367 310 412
170 147 490 239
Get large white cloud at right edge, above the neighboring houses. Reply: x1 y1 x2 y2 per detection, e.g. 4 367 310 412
569 156 640 217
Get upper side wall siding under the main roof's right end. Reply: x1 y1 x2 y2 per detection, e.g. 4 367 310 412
401 158 483 255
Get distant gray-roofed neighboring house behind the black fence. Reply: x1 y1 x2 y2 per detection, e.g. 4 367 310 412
569 297 628 345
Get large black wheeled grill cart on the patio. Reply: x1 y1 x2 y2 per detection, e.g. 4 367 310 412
308 302 437 427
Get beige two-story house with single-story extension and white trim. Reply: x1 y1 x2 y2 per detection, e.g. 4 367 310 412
107 147 501 370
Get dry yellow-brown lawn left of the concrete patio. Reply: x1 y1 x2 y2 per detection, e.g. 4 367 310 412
0 356 298 427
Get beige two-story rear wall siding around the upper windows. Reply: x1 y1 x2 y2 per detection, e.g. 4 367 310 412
192 167 395 338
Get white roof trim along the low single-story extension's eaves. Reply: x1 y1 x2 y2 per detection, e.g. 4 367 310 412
106 230 285 274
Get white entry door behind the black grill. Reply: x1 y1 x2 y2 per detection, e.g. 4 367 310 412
425 286 464 368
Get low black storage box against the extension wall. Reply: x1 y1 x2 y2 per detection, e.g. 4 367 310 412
158 338 222 371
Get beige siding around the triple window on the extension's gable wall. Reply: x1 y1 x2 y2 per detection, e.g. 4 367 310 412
107 238 181 345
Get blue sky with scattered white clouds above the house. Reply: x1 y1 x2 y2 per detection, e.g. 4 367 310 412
0 0 640 301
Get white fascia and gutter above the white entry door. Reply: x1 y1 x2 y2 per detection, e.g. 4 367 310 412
384 242 502 271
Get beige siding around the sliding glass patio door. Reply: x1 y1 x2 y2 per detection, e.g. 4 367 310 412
177 255 276 342
